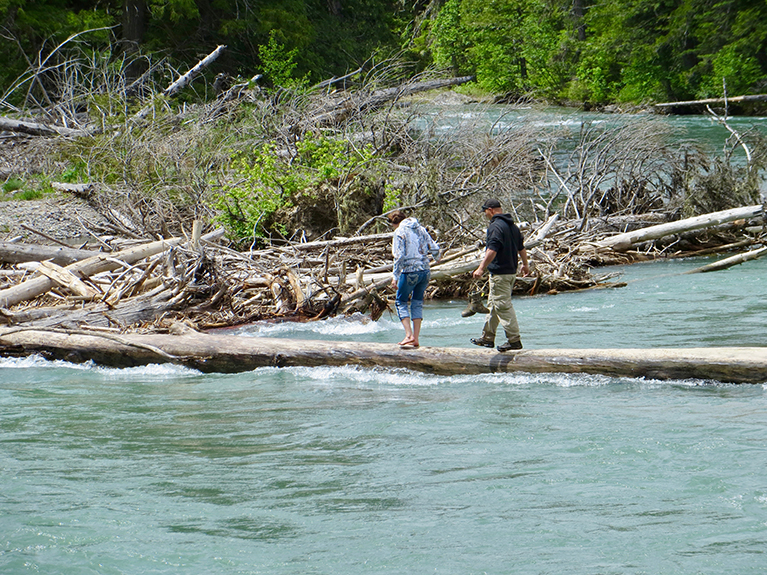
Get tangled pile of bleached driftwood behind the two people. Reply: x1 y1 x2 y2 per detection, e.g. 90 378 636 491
0 205 767 333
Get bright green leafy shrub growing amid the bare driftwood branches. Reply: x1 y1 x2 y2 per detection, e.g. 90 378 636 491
214 132 375 239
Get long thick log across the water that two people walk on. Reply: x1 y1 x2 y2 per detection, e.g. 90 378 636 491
0 327 767 383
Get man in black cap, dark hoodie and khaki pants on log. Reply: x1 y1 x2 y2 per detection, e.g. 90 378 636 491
471 198 530 351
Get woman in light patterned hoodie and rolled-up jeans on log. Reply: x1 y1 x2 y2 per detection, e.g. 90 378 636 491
387 210 440 347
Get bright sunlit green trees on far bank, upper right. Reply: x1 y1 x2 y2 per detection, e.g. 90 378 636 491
432 0 767 103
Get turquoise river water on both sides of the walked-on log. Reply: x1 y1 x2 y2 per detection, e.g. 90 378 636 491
0 260 767 575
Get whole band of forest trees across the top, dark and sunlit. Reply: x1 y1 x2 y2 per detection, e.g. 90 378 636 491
0 0 767 103
